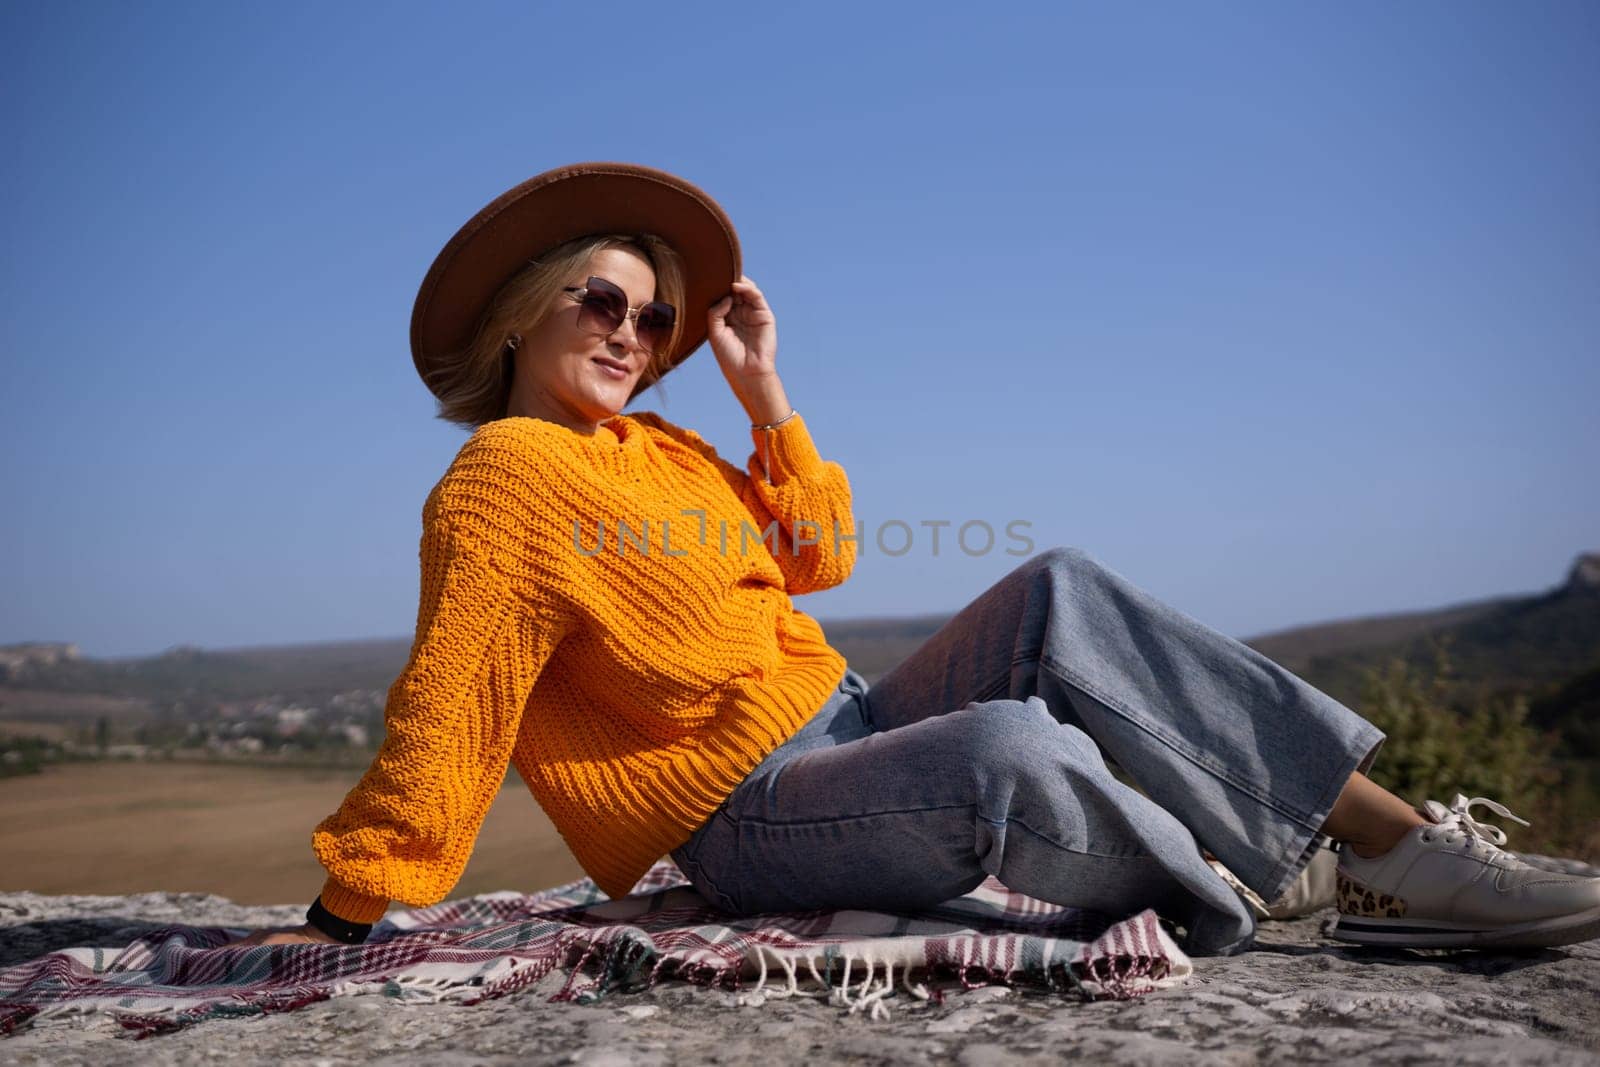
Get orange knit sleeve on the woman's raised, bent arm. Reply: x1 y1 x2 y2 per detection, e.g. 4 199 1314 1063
632 413 859 593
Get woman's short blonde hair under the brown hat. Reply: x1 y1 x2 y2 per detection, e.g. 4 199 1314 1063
427 234 685 430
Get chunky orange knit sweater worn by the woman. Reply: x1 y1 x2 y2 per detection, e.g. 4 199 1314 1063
312 411 856 923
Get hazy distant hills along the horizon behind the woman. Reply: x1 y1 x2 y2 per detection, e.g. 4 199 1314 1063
0 553 1600 758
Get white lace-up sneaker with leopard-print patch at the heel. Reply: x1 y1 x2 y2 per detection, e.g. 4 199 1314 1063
1330 793 1600 949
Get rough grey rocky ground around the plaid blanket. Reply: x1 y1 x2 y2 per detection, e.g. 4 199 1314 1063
0 863 1600 1067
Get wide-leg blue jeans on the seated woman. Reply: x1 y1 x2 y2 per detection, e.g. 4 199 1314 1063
672 549 1384 955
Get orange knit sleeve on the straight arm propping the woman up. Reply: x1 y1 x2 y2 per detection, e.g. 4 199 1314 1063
312 517 565 923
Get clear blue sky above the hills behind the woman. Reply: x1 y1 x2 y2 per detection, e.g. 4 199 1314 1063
0 0 1600 656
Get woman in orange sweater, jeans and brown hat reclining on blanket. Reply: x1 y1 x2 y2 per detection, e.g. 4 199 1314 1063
225 163 1600 955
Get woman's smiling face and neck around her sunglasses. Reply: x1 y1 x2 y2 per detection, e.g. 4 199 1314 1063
506 248 656 434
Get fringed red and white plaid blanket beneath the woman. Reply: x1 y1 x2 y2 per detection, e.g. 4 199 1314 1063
0 859 1192 1037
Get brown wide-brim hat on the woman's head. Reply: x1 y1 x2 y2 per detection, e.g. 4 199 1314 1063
411 163 742 400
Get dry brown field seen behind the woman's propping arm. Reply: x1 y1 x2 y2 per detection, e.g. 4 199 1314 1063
0 761 584 907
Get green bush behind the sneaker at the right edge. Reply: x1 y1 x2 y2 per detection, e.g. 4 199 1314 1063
1360 640 1600 862
